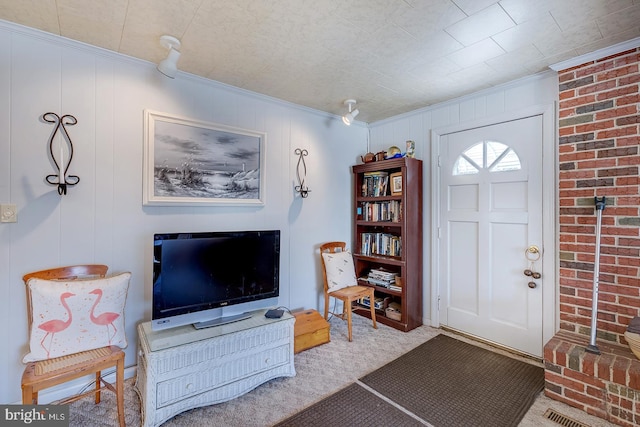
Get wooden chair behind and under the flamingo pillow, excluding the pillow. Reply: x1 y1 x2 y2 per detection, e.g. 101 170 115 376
22 264 125 427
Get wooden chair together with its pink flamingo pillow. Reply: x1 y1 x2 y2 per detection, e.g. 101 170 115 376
22 264 131 426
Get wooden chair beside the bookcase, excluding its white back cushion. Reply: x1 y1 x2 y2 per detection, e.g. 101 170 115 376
320 242 378 341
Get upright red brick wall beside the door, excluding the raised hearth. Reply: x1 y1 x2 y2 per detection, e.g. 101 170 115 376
559 48 640 343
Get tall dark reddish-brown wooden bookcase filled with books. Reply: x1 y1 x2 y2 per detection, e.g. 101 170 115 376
352 157 422 332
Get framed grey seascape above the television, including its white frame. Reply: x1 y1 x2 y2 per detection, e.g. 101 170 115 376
142 110 266 206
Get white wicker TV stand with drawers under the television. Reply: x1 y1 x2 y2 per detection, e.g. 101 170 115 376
136 310 296 427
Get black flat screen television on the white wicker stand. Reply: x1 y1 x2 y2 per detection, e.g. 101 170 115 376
151 230 280 330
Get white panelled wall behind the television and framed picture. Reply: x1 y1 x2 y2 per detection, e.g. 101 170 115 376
0 22 367 403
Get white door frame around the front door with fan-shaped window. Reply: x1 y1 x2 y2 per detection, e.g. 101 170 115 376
430 104 559 349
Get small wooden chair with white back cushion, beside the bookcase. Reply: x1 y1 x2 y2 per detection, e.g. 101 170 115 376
320 242 378 341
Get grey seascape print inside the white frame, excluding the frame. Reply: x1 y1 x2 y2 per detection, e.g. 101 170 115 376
152 119 264 203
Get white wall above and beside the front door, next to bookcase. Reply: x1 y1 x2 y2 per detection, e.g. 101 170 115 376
369 72 558 330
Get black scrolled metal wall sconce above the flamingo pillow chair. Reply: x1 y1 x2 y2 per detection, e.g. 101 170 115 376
42 112 80 195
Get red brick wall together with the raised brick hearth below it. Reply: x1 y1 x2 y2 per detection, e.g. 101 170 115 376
544 48 640 426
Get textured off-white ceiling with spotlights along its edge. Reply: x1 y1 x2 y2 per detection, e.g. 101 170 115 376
0 0 640 122
